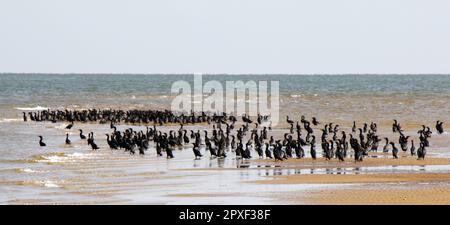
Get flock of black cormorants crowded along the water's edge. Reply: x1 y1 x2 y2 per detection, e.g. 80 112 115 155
23 109 444 161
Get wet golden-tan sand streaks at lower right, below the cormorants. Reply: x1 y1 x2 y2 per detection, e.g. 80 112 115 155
252 157 450 205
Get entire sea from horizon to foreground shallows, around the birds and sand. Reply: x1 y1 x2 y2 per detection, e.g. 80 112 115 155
0 75 450 204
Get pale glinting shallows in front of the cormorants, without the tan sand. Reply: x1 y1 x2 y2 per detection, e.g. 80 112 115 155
0 119 450 204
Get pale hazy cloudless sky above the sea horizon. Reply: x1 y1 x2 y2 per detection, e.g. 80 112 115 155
0 0 450 74
